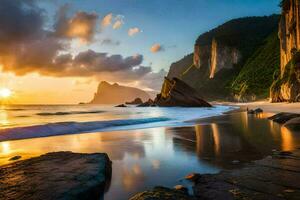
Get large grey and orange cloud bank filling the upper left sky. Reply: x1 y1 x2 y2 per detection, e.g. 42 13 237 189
0 0 161 90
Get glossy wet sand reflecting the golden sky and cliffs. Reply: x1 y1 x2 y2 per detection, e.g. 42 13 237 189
0 112 300 200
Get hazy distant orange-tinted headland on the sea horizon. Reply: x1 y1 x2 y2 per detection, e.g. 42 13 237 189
90 81 150 104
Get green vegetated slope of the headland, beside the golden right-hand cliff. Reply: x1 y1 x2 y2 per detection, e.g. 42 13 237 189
231 32 280 98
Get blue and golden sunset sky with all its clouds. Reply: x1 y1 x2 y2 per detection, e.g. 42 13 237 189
0 0 280 104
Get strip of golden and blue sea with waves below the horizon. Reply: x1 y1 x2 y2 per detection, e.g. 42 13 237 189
0 105 233 141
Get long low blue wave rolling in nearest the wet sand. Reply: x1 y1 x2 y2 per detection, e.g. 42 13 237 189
0 117 170 142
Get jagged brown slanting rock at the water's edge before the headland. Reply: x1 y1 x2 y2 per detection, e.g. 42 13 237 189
154 78 211 107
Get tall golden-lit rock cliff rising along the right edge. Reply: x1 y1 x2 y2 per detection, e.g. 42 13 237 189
270 0 300 102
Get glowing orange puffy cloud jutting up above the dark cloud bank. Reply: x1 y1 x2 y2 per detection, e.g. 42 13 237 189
54 5 98 42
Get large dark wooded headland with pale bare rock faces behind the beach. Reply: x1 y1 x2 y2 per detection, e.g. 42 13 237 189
168 15 279 100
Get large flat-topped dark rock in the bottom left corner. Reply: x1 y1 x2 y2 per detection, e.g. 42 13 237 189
0 152 111 200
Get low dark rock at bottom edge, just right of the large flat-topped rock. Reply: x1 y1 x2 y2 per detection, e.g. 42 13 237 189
130 186 195 200
